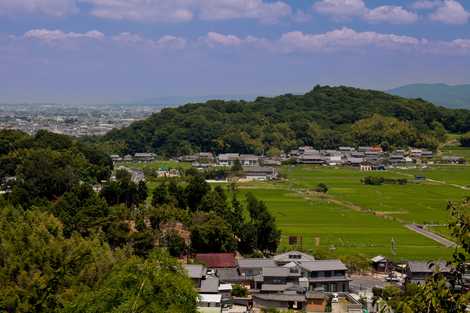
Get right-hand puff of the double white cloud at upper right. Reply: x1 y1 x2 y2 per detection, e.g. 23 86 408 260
364 5 418 24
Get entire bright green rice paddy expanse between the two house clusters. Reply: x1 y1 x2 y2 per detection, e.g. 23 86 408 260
240 165 470 260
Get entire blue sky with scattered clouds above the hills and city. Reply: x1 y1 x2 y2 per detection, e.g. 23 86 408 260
0 0 470 104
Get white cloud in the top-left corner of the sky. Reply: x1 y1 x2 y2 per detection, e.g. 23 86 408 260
0 0 78 17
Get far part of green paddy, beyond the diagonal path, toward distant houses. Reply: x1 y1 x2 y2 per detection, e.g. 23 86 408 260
283 166 470 224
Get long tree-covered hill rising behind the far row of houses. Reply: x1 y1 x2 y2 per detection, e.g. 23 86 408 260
101 86 470 156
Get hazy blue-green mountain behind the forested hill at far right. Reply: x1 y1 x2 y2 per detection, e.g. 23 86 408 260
387 84 470 109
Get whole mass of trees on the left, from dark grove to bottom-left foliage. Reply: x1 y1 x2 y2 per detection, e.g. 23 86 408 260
0 130 281 313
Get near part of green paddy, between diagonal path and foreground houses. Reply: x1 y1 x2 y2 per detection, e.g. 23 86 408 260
241 184 451 260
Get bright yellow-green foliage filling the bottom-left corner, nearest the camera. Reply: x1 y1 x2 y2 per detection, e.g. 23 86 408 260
0 208 197 313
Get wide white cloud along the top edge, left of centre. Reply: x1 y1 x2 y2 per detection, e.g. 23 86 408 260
79 0 292 22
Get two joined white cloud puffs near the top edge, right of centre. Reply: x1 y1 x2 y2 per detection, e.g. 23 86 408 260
313 0 418 24
